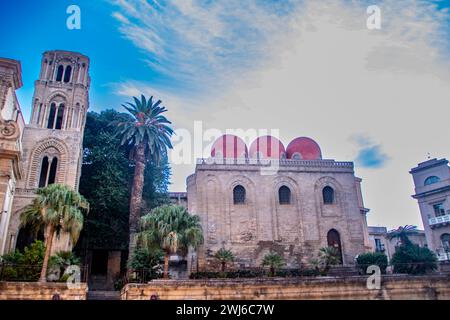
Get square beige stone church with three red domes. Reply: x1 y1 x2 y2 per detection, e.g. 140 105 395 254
187 135 371 270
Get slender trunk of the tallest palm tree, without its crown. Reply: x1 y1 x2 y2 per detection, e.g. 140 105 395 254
128 143 145 261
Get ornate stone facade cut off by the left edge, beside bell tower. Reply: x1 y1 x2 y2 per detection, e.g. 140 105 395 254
0 58 25 255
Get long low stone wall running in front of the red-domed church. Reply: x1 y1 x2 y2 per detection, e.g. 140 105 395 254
121 276 450 300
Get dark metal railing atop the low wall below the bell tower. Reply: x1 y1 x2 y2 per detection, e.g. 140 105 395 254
0 262 89 283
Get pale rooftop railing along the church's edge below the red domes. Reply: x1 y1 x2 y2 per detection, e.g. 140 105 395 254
197 157 353 168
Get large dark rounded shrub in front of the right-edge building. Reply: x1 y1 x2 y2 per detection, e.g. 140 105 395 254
391 240 437 275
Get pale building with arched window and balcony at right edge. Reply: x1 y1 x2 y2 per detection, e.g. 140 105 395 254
410 159 450 262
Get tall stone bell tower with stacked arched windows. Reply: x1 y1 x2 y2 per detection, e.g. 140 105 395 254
6 50 90 252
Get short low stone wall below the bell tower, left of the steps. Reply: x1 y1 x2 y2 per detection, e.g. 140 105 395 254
0 282 87 300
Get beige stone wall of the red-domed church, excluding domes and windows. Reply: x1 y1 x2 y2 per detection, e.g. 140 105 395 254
187 160 368 270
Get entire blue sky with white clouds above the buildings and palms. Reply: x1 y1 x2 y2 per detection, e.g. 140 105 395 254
0 0 450 227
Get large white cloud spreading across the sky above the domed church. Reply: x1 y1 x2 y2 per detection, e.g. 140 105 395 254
110 0 450 228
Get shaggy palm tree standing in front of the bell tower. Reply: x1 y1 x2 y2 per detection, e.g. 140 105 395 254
20 184 89 282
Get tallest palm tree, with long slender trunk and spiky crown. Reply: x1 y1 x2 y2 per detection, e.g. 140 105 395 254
114 95 173 260
